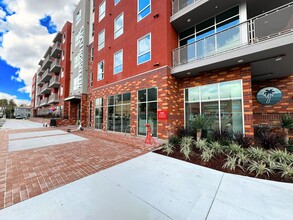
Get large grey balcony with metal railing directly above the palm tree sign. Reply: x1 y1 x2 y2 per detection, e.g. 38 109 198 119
171 2 293 81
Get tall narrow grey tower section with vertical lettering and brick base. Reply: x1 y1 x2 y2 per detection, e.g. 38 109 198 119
65 0 94 126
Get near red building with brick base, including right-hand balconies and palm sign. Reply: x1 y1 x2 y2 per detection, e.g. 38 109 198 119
88 0 293 138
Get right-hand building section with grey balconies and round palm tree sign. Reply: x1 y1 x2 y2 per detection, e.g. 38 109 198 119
170 0 293 135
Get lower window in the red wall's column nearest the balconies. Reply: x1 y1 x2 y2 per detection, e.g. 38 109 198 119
137 34 151 64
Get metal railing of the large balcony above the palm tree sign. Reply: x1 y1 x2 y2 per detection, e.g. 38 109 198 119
173 2 293 67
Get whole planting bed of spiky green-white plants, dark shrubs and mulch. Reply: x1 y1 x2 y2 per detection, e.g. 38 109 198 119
155 114 293 183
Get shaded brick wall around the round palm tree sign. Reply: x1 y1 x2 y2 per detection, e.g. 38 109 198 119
252 75 293 127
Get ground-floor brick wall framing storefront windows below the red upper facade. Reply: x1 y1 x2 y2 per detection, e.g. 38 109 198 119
88 67 178 138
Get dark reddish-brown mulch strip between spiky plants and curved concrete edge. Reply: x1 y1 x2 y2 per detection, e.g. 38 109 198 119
154 147 292 183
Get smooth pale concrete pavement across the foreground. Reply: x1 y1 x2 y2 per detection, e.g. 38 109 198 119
0 153 293 220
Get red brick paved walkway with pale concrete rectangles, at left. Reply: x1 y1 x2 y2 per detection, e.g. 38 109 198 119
0 120 148 209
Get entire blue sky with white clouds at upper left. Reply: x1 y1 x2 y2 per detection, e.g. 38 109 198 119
0 0 79 105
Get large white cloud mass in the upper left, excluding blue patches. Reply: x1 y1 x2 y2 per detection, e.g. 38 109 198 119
0 0 79 93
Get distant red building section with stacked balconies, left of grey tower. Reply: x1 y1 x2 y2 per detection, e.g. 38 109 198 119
32 22 72 118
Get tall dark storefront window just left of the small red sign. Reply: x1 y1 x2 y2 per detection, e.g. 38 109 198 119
137 88 158 137
